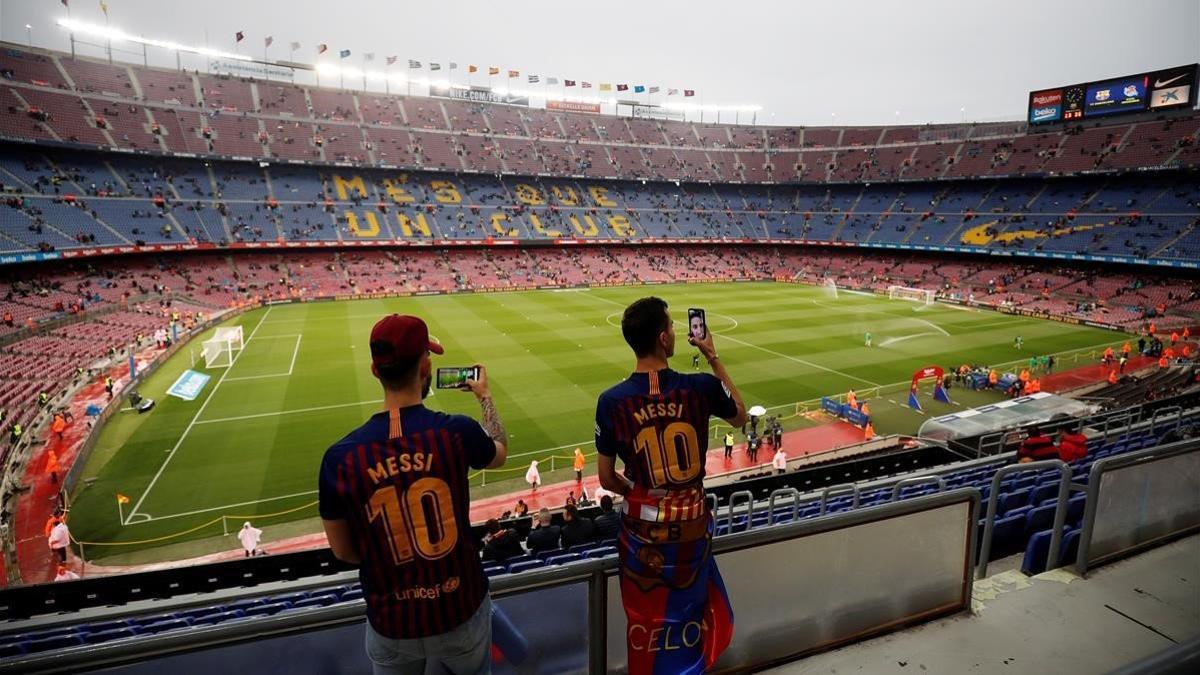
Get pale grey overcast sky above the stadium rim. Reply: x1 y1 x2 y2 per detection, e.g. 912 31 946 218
0 0 1200 125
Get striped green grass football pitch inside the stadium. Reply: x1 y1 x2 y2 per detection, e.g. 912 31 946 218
71 283 1121 561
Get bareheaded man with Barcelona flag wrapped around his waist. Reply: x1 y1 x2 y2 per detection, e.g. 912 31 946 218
596 298 746 674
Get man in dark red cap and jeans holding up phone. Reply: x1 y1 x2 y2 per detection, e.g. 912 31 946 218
319 315 508 674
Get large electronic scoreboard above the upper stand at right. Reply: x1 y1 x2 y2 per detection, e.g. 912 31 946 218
1027 64 1198 124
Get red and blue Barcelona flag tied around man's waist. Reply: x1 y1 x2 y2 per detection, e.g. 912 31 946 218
618 486 733 675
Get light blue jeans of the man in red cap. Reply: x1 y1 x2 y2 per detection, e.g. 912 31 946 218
367 596 492 675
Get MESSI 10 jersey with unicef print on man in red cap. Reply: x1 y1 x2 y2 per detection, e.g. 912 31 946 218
319 405 496 639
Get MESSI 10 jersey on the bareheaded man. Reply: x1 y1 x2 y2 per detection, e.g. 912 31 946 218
595 369 738 490
